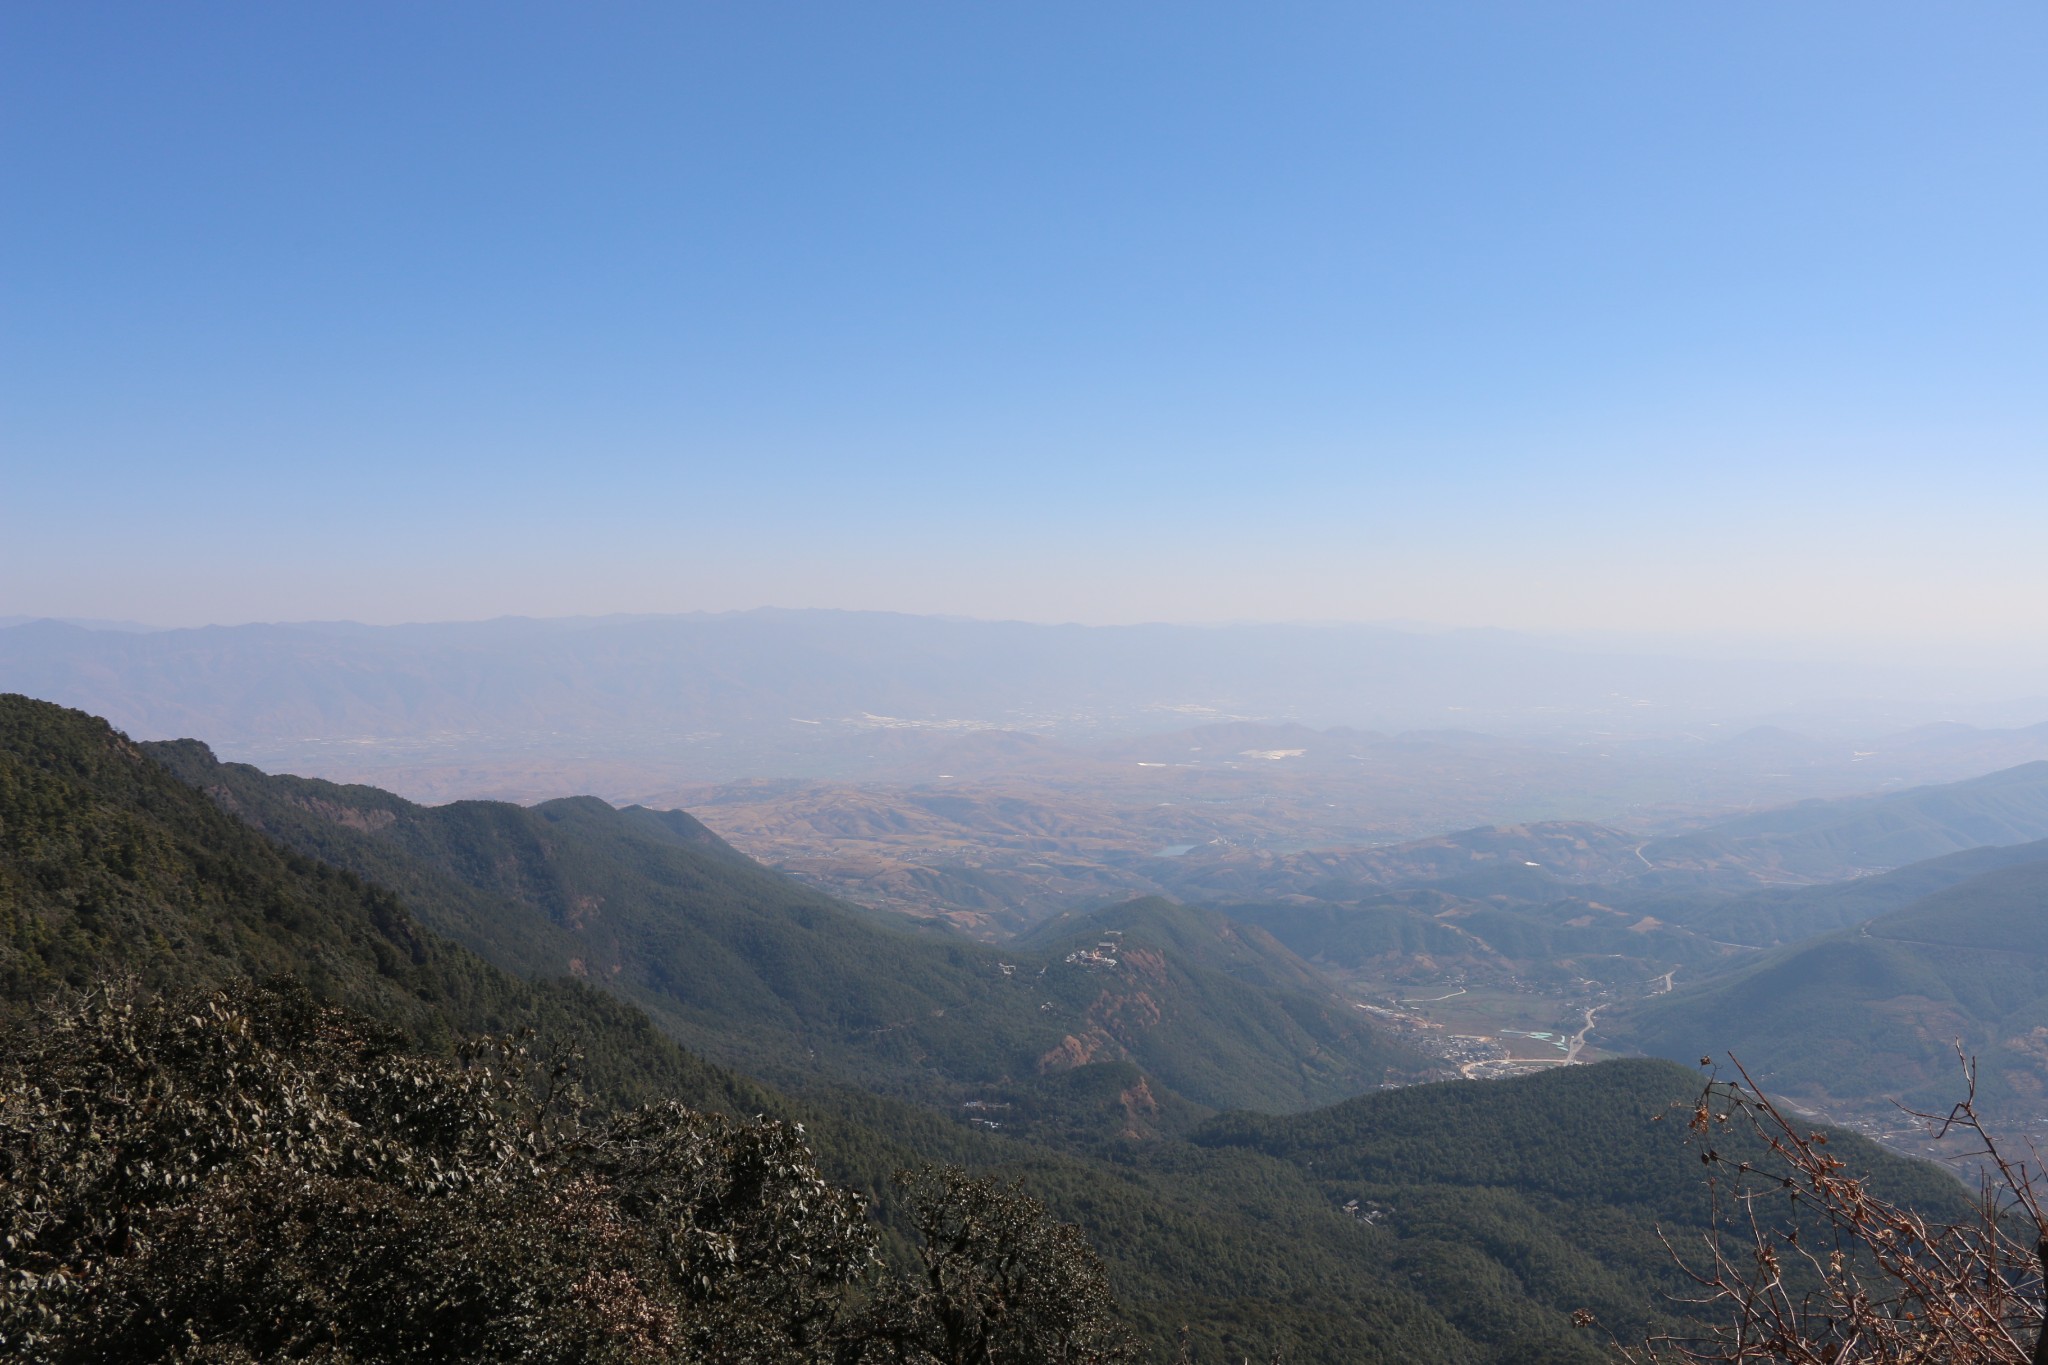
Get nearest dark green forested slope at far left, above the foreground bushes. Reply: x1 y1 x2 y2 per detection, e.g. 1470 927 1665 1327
0 696 766 1113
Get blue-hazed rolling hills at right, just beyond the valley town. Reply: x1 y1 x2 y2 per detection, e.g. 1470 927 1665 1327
1184 763 2048 1015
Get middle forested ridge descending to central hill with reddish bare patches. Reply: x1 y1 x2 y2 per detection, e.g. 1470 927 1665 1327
147 741 1425 1107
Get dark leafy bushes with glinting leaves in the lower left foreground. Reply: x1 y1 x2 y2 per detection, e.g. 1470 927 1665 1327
0 988 1133 1365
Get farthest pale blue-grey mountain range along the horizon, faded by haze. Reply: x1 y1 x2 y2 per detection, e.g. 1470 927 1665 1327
0 610 2048 780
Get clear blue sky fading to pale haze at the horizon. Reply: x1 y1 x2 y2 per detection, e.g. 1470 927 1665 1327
0 0 2048 639
